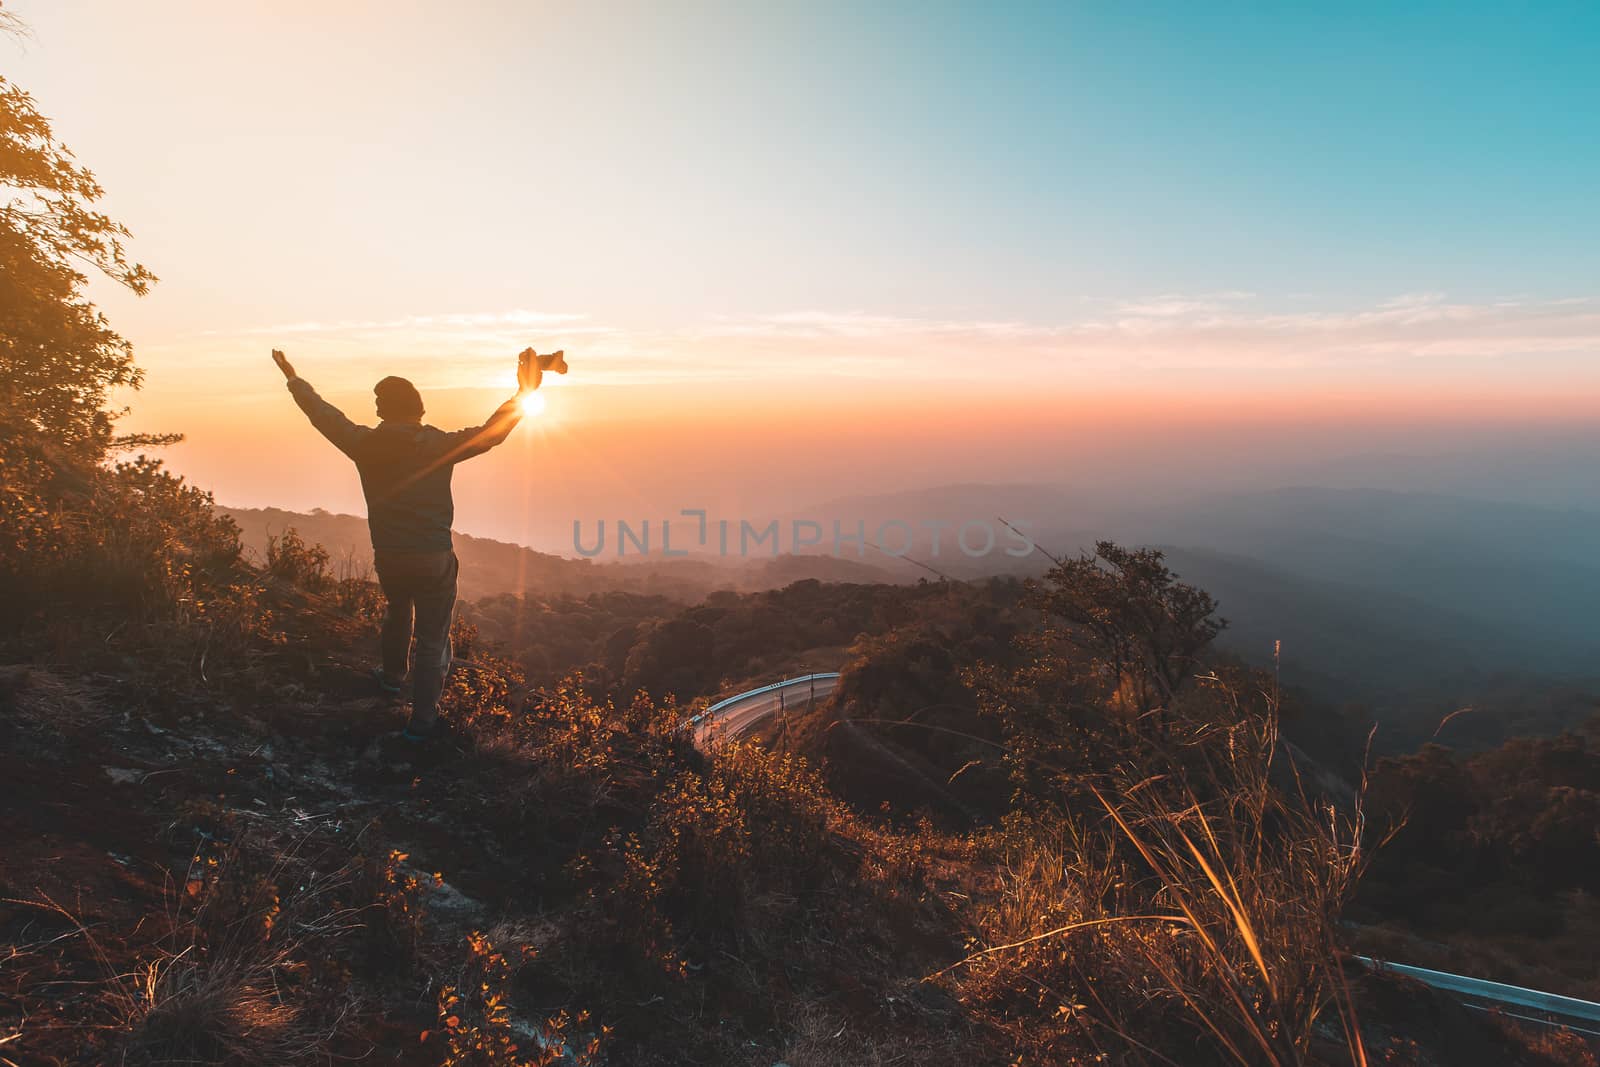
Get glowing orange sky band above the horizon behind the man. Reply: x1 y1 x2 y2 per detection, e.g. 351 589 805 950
121 350 1597 553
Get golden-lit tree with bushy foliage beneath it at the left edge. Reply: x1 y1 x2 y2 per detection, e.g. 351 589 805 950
0 43 240 640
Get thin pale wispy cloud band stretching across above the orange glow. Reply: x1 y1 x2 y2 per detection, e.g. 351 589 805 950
165 291 1600 384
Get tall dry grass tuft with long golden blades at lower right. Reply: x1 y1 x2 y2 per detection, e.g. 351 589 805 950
933 678 1368 1067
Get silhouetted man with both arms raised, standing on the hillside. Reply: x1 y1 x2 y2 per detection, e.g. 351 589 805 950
272 349 541 741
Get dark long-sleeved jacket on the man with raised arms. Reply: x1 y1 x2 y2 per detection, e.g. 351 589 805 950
290 378 522 552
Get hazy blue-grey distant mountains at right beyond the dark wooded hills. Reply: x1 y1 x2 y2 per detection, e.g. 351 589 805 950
780 485 1600 713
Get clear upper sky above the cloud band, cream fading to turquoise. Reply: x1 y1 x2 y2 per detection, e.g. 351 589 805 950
6 0 1600 320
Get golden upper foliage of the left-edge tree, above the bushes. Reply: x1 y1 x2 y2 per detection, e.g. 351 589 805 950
0 77 155 459
